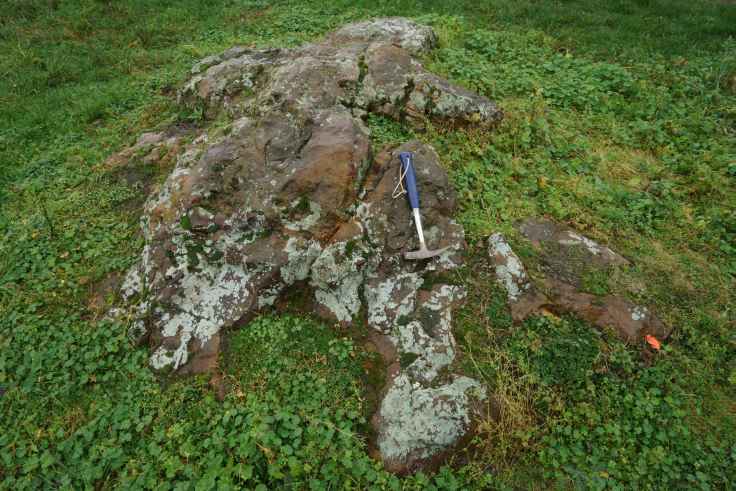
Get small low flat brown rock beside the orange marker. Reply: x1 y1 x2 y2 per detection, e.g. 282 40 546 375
488 220 670 342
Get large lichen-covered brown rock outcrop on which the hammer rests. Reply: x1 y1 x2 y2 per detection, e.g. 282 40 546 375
113 19 501 472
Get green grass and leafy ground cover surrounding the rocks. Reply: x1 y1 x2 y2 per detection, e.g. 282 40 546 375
0 0 736 489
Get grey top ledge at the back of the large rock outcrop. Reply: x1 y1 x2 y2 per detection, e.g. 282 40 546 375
179 18 503 125
